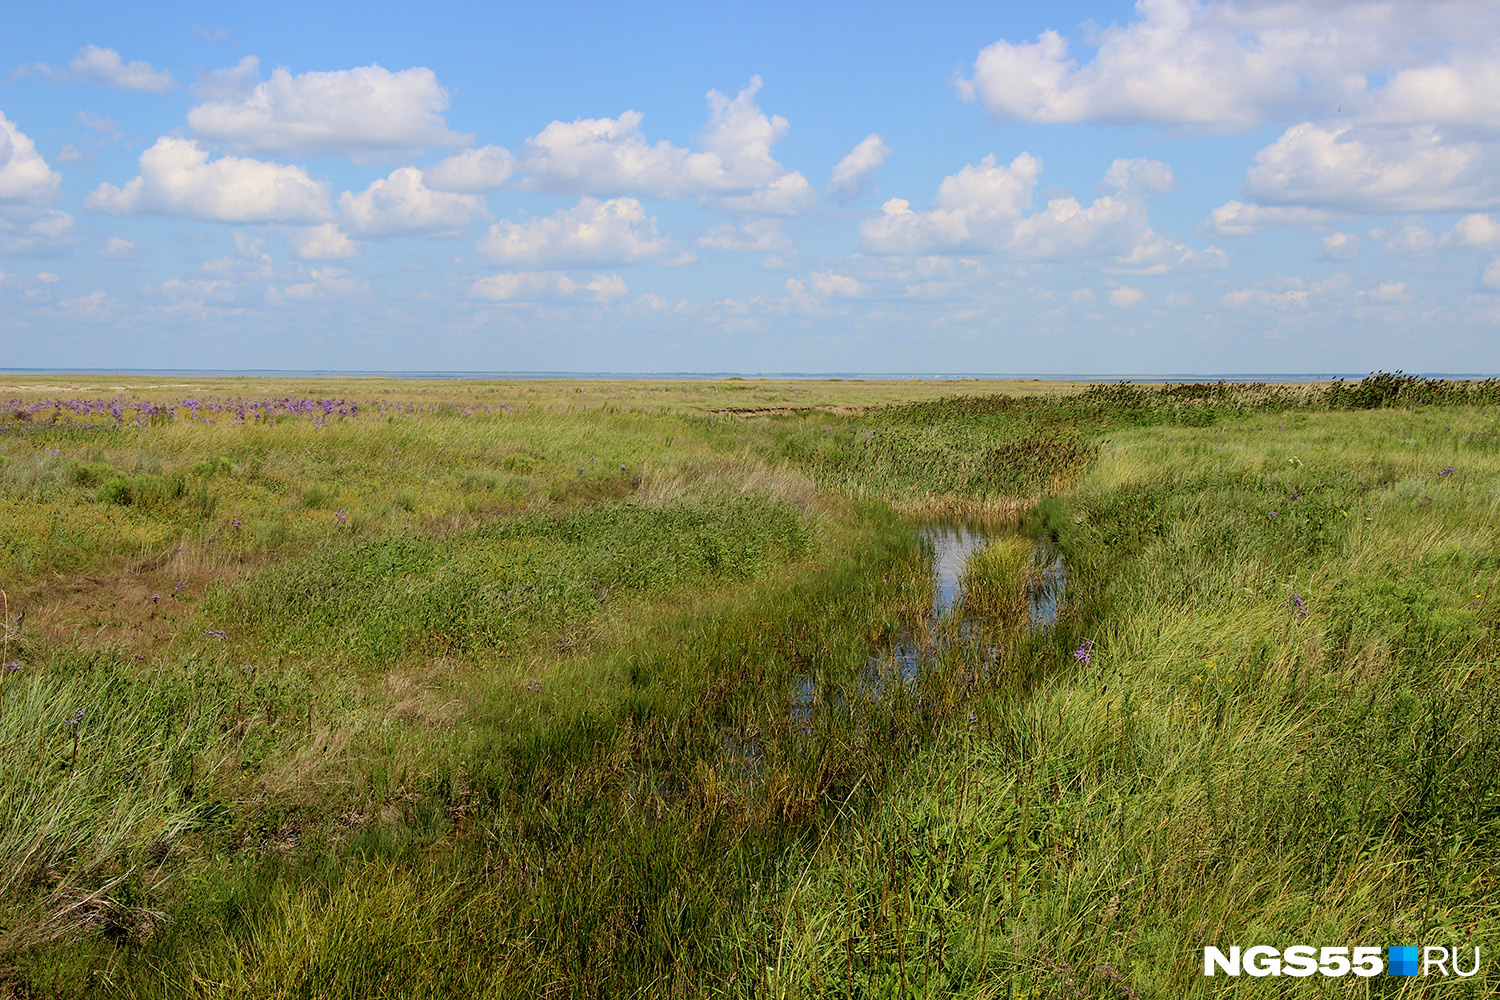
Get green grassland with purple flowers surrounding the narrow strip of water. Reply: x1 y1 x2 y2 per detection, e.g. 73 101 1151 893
0 376 1500 999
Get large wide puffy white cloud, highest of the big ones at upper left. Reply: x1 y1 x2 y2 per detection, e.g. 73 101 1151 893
188 61 471 159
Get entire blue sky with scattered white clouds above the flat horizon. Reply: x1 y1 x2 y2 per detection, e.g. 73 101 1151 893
0 0 1500 375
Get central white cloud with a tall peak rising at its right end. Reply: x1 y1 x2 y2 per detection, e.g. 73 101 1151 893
522 76 812 214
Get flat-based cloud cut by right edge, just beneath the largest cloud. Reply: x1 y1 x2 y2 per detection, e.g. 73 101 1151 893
1245 121 1500 211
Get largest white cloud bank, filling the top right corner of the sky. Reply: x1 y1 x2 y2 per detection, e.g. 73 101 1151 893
957 0 1500 132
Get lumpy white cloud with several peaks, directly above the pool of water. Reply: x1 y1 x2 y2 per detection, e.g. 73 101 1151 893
860 153 1227 274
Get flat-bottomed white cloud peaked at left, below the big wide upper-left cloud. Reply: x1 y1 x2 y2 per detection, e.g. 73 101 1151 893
84 136 330 222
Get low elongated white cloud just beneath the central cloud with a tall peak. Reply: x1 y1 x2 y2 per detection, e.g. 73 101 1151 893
479 198 671 268
